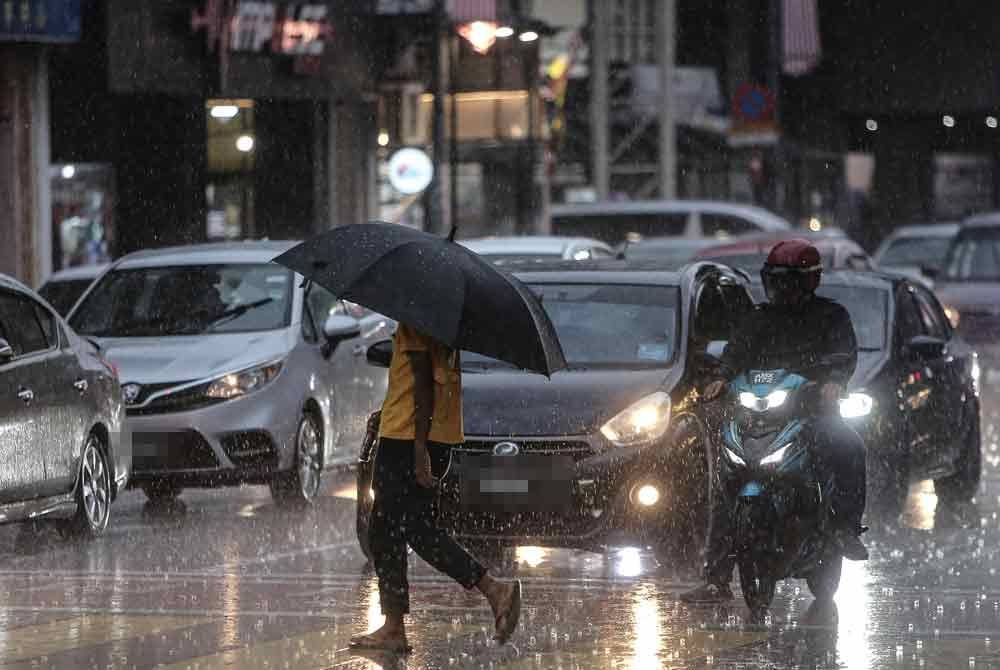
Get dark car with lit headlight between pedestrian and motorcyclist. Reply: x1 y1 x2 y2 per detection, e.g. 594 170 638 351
358 263 753 552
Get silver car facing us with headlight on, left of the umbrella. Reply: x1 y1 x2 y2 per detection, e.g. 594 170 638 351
70 242 391 510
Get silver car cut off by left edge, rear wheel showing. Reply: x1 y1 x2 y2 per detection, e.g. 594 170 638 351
0 275 132 535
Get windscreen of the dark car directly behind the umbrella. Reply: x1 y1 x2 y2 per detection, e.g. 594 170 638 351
462 284 680 369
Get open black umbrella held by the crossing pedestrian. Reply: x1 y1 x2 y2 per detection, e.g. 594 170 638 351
274 223 566 375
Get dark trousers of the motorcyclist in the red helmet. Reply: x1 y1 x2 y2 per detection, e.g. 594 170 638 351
705 417 867 585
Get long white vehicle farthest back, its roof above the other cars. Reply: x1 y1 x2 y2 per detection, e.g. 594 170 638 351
551 200 792 245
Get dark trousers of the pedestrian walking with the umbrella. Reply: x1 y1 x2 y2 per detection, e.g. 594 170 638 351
369 438 486 615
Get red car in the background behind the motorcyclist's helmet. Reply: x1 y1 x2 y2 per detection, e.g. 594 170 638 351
694 231 874 271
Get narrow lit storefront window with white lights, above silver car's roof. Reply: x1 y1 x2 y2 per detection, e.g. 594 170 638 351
205 100 257 240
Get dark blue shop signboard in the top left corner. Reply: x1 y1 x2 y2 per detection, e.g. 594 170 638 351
0 0 80 42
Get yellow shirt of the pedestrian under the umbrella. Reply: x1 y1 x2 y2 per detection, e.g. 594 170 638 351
379 324 465 444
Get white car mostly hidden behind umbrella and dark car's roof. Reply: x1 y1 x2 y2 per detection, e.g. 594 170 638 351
459 235 615 266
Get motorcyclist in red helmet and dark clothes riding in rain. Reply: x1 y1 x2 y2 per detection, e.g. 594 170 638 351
681 239 868 603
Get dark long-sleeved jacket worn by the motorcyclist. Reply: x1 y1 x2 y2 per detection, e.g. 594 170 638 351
722 296 858 386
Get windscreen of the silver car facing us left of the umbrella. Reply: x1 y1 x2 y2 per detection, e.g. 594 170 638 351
71 263 294 337
